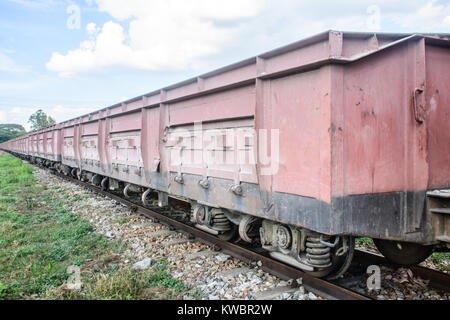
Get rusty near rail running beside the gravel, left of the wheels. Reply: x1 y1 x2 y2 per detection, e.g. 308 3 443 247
26 164 371 300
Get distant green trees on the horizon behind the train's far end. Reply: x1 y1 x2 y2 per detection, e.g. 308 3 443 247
0 110 56 143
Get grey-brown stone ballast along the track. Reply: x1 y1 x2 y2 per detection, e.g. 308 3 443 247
34 168 450 300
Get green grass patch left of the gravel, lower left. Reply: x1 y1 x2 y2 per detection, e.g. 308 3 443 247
0 155 189 300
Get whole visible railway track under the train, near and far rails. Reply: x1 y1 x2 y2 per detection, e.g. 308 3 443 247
22 160 450 300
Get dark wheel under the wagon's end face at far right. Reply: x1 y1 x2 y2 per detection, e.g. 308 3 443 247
373 239 433 266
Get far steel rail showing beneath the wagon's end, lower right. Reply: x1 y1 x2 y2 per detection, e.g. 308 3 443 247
353 249 450 292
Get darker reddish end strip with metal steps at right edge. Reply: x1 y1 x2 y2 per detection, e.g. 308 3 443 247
423 39 450 244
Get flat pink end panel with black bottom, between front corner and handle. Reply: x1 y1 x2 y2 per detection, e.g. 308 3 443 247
332 38 430 241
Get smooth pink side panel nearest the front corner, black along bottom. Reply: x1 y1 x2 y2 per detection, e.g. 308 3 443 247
256 66 331 233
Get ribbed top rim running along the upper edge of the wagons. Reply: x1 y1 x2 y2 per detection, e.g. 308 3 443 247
2 30 450 141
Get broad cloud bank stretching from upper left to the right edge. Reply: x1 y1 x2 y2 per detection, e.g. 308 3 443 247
37 0 450 77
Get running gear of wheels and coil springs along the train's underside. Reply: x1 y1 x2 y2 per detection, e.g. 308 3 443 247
18 155 444 279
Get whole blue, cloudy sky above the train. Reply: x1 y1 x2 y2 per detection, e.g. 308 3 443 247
0 0 450 130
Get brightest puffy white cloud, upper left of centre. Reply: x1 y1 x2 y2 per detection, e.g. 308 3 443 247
46 0 265 77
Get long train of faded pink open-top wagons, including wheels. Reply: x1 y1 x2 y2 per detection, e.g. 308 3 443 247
1 31 450 278
